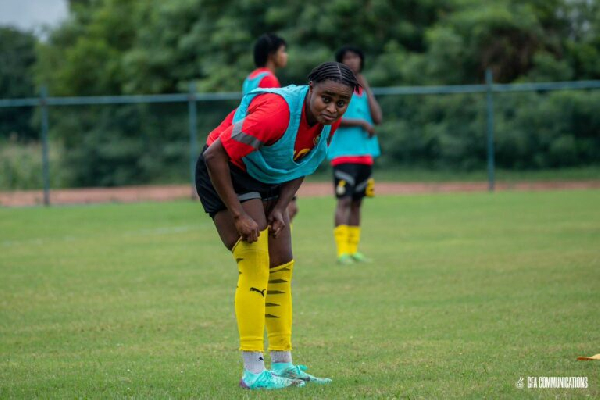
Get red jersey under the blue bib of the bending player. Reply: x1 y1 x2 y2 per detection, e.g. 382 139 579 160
206 93 341 170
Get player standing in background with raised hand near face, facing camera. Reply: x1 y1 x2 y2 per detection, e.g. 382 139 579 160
328 46 382 264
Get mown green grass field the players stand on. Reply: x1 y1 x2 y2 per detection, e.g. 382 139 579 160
0 191 600 399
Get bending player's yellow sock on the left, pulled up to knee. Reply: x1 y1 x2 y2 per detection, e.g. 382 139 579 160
233 229 269 352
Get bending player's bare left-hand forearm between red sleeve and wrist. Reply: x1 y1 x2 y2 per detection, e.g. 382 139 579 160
204 139 244 218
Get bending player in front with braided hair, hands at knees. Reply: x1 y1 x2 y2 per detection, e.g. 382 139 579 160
196 62 358 389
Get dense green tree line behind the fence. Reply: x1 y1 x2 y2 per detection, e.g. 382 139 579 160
0 0 600 185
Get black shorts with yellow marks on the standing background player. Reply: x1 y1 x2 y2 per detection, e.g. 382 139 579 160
333 164 374 200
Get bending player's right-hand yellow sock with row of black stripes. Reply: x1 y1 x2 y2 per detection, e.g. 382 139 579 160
265 260 294 351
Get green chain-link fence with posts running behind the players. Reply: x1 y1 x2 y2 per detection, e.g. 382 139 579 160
0 73 600 204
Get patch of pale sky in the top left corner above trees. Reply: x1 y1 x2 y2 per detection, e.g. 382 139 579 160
0 0 67 30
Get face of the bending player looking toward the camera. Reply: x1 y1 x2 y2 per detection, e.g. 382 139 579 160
307 81 352 125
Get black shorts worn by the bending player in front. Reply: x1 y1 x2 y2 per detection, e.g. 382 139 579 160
196 147 281 218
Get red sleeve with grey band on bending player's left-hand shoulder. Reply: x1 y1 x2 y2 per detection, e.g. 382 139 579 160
220 93 290 166
